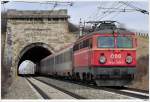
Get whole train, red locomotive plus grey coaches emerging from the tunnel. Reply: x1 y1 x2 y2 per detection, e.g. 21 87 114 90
40 21 136 86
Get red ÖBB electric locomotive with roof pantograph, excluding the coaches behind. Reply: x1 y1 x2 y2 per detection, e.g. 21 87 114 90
73 21 136 86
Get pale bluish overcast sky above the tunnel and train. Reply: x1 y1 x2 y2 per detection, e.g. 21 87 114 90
1 0 149 32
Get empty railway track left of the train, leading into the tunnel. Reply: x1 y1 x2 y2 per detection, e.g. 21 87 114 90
26 78 86 99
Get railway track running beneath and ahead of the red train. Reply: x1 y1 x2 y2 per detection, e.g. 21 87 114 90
35 78 149 99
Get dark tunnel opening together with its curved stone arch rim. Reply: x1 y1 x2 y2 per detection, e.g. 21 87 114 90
17 42 54 73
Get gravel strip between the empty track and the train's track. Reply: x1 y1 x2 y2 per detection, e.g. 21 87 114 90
37 77 133 99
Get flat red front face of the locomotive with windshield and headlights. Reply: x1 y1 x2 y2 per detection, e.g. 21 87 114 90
91 32 136 86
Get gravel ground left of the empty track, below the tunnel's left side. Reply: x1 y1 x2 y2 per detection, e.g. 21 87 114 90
4 77 40 99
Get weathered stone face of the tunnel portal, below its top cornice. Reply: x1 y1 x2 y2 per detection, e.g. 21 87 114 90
5 9 76 77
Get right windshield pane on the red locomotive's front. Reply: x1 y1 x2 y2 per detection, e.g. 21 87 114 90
117 36 132 48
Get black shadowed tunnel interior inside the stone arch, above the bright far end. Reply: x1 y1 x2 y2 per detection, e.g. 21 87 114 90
17 45 52 75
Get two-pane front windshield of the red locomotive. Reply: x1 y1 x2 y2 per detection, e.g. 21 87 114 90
97 36 132 48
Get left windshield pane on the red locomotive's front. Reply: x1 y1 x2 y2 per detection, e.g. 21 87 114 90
98 36 115 48
